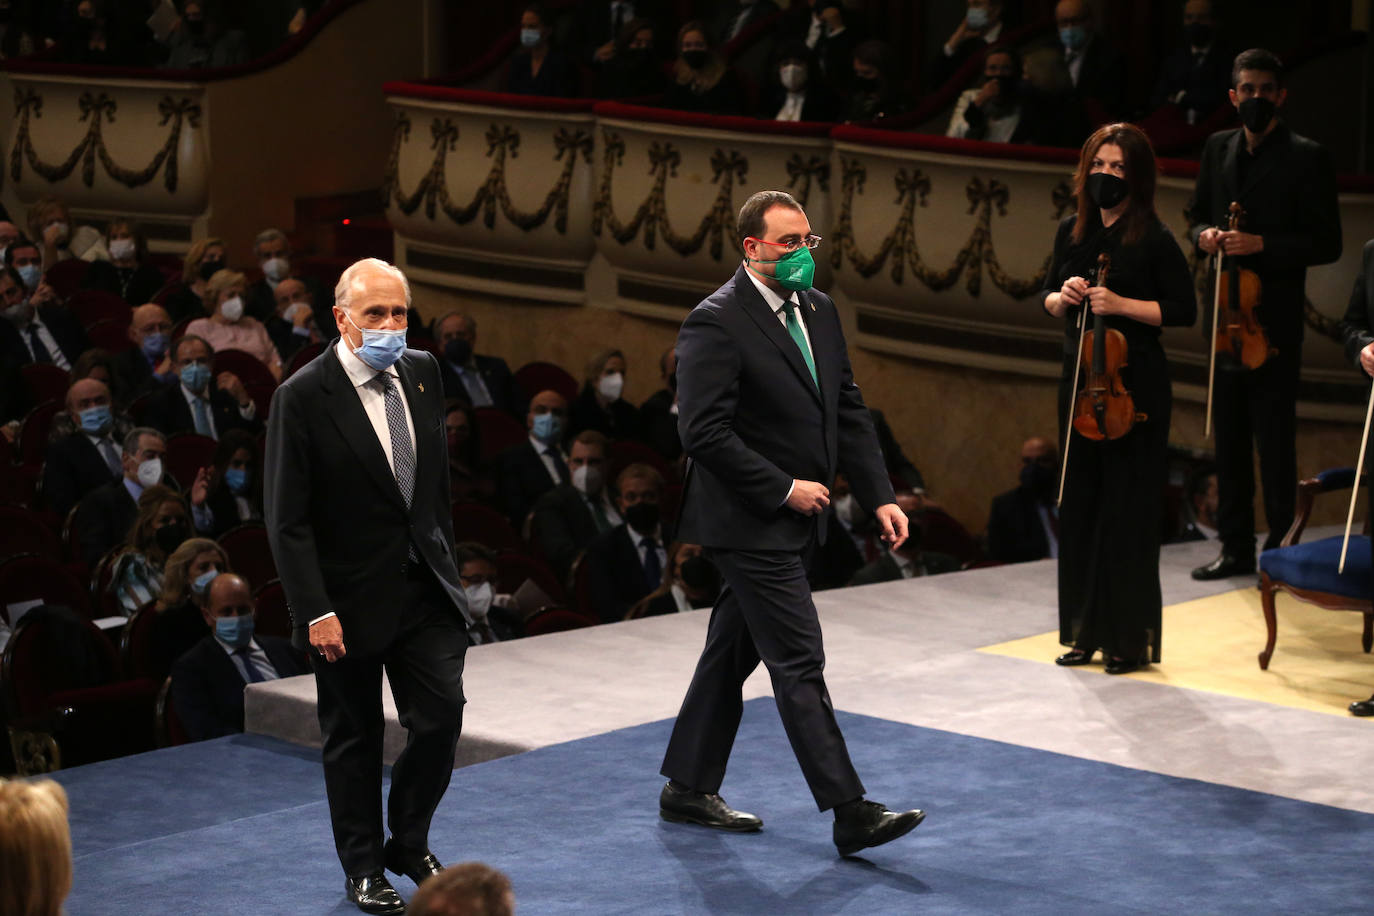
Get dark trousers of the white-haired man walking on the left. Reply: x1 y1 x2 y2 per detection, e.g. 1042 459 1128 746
311 566 467 875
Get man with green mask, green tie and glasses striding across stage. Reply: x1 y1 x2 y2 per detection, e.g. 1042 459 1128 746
660 191 925 856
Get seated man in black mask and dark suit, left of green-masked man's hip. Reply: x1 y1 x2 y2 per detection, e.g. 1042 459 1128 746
583 464 668 623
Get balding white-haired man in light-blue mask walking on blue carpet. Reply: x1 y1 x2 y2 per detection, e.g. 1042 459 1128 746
264 258 470 913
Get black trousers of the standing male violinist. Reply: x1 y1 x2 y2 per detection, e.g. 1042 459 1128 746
1212 343 1301 558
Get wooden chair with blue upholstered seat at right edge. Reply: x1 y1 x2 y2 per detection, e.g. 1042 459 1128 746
1260 467 1374 669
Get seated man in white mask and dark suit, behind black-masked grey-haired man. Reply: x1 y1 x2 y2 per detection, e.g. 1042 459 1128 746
533 430 622 578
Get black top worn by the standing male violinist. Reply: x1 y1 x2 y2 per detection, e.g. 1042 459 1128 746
1189 124 1341 349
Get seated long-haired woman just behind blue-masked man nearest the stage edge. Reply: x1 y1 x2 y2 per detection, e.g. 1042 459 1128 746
147 537 234 678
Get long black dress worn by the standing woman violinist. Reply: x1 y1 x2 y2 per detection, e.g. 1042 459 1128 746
1041 213 1197 662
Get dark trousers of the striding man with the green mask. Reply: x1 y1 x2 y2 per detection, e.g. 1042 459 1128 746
661 549 864 810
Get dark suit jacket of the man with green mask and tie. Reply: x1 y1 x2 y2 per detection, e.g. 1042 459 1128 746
677 266 894 551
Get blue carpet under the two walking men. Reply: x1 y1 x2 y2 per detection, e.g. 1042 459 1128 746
58 699 1374 916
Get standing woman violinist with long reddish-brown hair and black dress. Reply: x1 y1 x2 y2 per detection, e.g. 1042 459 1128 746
1043 124 1197 674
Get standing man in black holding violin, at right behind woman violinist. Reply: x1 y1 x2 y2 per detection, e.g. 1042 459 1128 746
1189 48 1341 580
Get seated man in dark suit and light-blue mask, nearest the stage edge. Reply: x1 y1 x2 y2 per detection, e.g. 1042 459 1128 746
172 573 311 742
